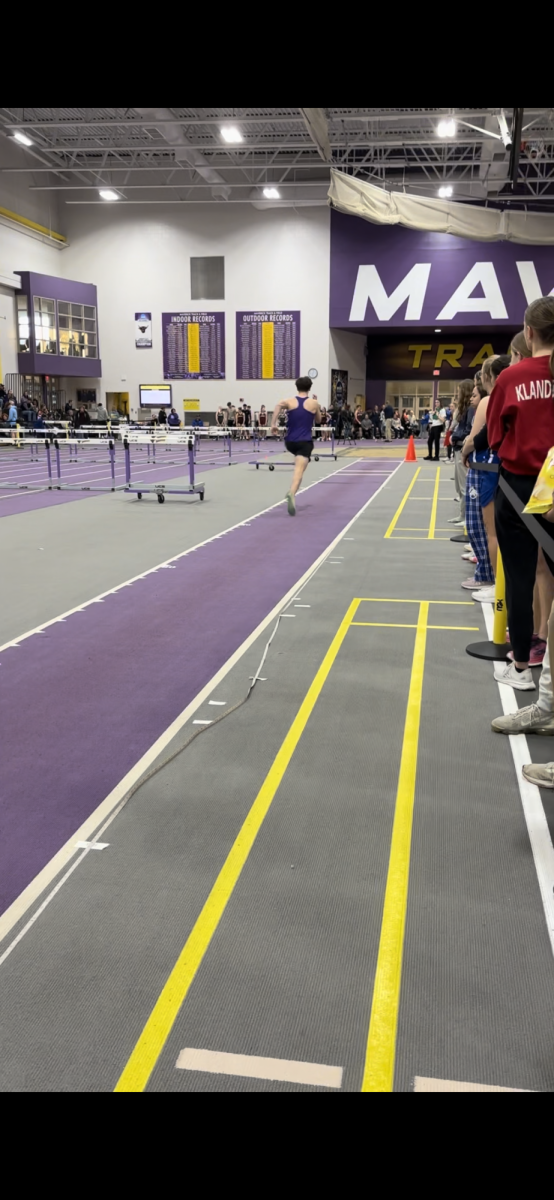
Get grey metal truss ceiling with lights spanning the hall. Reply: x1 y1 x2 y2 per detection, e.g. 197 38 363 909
0 107 554 210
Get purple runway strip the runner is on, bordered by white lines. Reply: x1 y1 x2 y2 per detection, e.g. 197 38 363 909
0 463 396 912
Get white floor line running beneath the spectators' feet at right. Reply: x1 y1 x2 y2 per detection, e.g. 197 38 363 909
482 604 554 954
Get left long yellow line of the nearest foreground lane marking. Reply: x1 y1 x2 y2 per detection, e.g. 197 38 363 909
115 600 360 1092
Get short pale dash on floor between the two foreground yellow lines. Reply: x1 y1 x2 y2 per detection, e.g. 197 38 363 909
175 1046 343 1088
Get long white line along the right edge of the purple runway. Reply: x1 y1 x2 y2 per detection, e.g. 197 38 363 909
0 463 403 950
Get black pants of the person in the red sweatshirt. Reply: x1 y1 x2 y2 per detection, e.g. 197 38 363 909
494 467 554 662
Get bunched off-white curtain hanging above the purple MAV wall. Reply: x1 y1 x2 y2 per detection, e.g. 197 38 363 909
327 170 554 246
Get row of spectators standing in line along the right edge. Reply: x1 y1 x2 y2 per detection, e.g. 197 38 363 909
427 296 554 788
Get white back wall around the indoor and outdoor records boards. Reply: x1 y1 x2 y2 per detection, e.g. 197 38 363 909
61 202 328 416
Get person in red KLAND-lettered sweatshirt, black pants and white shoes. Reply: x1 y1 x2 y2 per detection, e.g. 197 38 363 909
487 296 554 691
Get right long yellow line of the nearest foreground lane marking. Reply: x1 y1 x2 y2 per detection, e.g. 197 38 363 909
362 601 429 1092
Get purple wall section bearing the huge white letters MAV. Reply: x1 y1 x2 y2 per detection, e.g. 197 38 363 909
330 210 554 334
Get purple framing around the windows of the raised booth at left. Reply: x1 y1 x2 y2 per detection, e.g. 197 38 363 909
14 271 102 379
